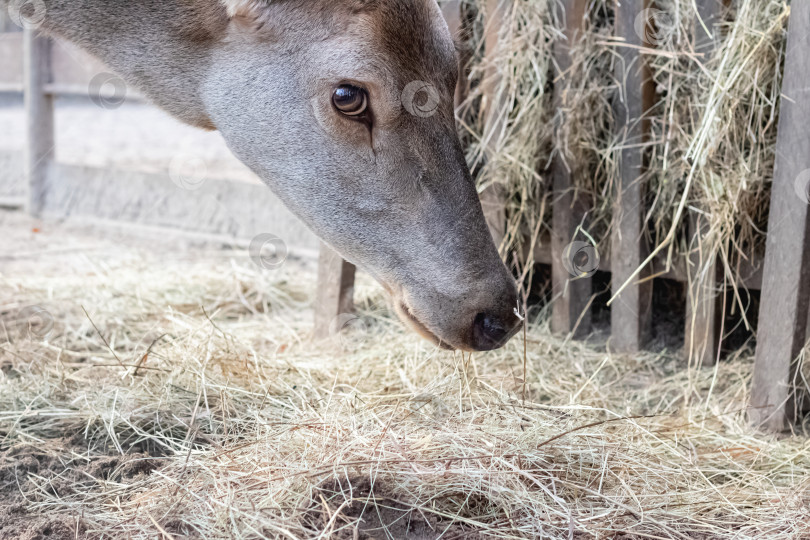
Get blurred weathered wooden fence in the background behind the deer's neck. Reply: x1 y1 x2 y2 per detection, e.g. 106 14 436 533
0 30 318 254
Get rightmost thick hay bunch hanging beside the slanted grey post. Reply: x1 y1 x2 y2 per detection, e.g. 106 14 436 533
649 0 790 278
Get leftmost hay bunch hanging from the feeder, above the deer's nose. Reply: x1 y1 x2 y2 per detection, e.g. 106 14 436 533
459 1 559 260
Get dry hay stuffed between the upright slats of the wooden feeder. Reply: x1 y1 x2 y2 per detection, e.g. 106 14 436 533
462 0 790 296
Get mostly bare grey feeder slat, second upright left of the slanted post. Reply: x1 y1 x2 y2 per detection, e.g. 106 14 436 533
610 0 653 352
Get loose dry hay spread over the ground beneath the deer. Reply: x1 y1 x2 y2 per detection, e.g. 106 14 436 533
0 233 810 539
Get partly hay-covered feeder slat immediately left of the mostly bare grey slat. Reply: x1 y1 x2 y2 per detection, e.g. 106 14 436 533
551 0 592 337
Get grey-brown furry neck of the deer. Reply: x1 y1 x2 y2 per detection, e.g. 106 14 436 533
28 0 228 129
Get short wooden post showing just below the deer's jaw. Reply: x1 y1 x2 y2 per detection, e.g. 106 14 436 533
315 242 355 338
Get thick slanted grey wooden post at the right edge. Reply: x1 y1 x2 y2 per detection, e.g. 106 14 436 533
750 2 810 431
